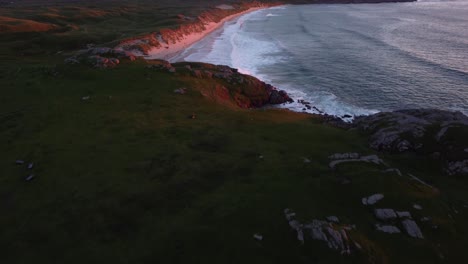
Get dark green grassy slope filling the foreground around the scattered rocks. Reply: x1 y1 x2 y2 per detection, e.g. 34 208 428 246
0 2 468 263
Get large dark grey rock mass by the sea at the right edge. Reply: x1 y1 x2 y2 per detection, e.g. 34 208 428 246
354 109 468 175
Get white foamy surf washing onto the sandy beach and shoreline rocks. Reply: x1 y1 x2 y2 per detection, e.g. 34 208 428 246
176 7 377 116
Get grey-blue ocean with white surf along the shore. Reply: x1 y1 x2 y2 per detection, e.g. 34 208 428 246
172 1 468 116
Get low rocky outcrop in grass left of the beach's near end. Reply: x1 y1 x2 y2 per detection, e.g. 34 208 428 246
65 47 136 69
